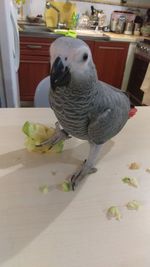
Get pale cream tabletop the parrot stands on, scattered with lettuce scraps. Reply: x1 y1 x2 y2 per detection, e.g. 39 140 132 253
0 107 150 267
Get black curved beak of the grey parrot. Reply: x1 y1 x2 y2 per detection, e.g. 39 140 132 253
50 57 71 90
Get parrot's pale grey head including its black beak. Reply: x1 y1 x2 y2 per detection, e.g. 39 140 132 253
50 37 97 90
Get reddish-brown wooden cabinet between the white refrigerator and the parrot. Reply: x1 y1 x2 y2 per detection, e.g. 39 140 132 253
19 37 54 101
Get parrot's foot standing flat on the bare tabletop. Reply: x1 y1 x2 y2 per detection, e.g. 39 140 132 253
70 160 97 191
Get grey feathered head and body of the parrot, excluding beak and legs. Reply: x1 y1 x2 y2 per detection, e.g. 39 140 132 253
50 37 130 144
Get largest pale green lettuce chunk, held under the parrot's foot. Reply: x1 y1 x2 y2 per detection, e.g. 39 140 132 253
22 121 64 153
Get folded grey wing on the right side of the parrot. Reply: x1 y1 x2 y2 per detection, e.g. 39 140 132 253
88 81 130 144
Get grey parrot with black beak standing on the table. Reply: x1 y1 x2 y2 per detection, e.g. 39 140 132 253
39 37 137 190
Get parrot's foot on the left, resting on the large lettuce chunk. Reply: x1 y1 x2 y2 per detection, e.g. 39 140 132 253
36 122 71 149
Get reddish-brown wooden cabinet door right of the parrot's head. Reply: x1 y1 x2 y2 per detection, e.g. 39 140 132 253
93 41 129 88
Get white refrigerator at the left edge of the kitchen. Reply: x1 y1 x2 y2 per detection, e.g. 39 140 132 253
0 0 20 107
